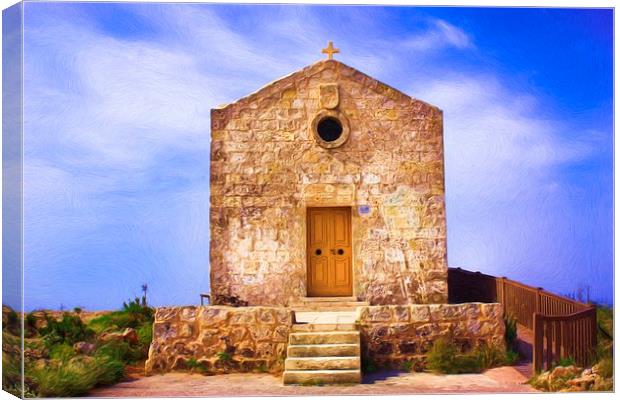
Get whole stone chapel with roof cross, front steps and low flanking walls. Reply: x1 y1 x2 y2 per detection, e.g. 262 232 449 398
145 47 506 385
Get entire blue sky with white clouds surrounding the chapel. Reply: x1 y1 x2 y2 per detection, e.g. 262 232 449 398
12 3 613 309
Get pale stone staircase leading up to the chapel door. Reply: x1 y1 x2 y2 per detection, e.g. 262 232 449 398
283 297 366 385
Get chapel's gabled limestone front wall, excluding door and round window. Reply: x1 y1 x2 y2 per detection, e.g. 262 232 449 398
210 60 447 306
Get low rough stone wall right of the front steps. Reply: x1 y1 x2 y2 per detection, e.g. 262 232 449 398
358 303 505 368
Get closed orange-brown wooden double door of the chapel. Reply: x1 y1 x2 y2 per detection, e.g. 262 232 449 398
307 207 353 297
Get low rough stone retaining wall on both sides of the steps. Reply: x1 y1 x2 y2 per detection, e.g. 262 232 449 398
145 303 505 374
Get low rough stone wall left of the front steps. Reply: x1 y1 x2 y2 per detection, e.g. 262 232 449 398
145 306 293 374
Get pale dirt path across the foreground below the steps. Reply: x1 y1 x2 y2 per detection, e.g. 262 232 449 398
91 367 535 397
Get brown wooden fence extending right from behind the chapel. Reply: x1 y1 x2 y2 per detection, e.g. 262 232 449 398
448 268 597 372
